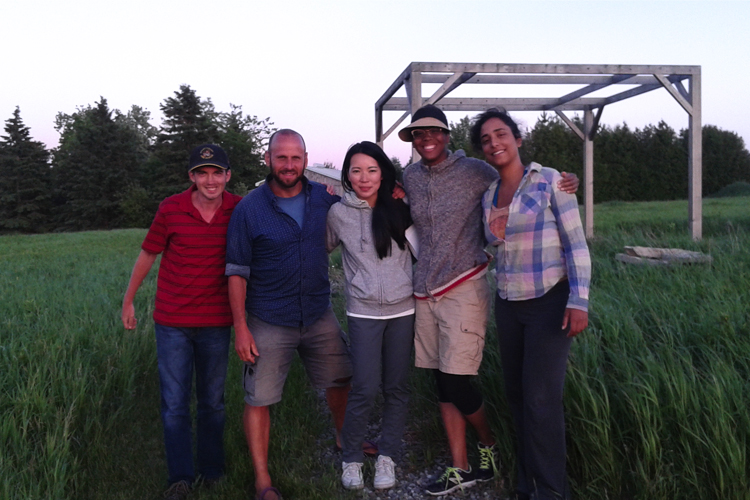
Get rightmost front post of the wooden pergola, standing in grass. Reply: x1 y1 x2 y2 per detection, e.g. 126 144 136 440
688 72 703 240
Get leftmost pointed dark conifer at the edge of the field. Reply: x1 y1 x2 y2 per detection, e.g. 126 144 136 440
0 106 52 232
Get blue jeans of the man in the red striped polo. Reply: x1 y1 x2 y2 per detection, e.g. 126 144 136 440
155 324 230 484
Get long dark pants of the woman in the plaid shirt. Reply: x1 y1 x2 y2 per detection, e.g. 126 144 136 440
495 280 572 500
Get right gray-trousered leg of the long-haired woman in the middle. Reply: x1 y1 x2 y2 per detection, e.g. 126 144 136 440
376 315 414 460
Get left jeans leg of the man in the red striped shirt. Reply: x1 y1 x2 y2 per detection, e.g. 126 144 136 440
155 324 195 484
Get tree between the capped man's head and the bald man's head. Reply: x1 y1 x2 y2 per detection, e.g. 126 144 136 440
216 104 275 195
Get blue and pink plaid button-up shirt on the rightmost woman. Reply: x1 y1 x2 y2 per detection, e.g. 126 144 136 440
482 163 591 311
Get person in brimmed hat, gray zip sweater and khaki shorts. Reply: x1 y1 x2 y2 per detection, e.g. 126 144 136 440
398 104 578 496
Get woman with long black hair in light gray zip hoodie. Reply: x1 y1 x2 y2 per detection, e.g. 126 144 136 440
326 141 414 489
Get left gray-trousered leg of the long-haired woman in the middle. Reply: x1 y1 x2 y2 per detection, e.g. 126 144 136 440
342 317 387 462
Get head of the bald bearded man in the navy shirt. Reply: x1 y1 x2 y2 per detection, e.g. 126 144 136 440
265 134 307 196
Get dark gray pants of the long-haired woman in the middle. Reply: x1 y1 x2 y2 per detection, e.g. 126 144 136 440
341 314 414 462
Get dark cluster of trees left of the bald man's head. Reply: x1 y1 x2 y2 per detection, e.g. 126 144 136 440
0 85 274 233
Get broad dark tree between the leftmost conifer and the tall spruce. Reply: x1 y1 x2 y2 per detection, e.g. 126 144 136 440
53 97 143 230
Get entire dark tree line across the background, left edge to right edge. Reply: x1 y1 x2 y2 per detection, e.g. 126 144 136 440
0 97 750 233
